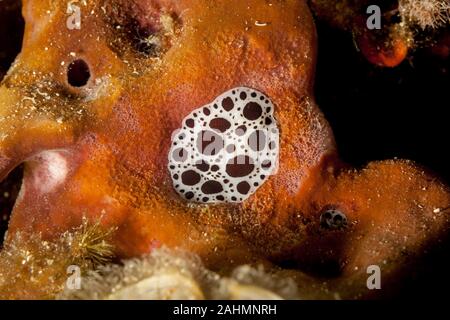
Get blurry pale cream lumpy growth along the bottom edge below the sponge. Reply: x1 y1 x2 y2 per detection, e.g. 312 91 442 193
57 247 298 300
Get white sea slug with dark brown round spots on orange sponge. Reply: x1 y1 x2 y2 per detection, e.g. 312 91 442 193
168 87 279 203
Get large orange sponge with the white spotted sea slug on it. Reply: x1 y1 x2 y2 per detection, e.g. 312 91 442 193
0 0 450 298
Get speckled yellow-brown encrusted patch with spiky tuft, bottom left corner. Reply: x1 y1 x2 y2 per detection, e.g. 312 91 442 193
0 219 114 299
